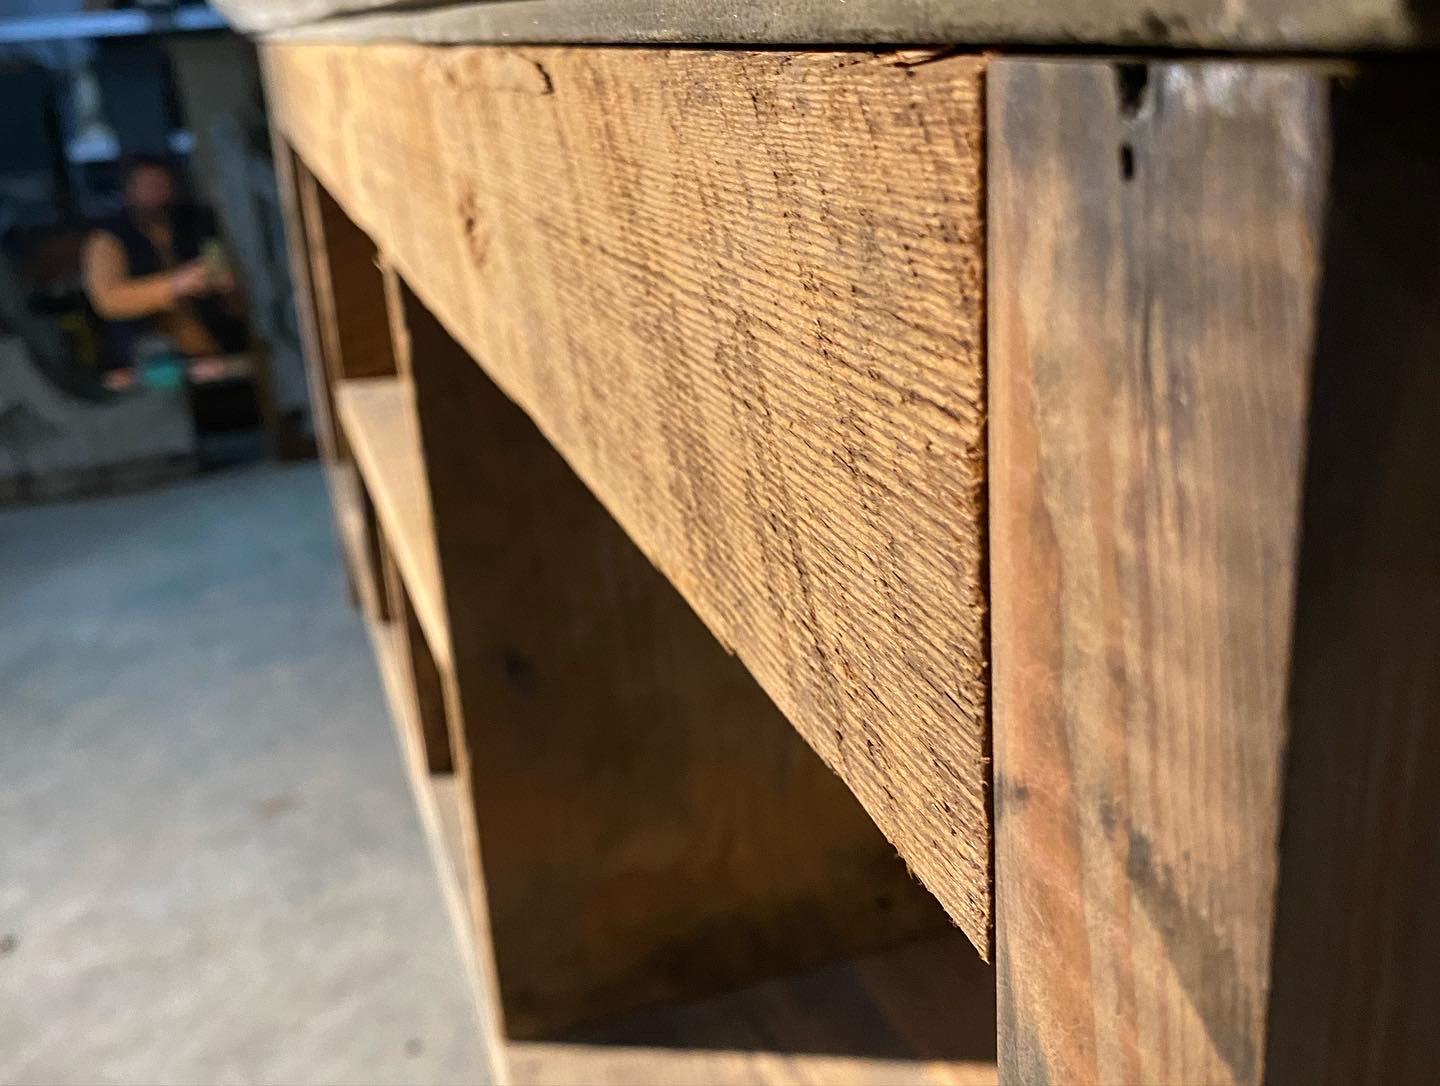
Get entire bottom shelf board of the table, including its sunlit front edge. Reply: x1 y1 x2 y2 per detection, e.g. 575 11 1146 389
357 558 996 1086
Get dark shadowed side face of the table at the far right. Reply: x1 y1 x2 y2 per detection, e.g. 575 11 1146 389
1266 62 1440 1086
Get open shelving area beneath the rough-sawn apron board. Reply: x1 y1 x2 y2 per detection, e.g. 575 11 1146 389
283 150 995 1086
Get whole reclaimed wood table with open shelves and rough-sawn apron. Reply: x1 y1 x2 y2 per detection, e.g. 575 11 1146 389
222 0 1440 1086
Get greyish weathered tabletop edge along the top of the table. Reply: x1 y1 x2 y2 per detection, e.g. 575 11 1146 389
208 0 1437 49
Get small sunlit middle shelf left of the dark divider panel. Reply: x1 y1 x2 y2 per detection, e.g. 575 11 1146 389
334 377 451 667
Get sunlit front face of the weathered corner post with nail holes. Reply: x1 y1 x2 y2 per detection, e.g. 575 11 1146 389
989 60 1328 1083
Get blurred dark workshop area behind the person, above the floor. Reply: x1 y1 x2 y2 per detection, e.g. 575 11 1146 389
0 0 312 481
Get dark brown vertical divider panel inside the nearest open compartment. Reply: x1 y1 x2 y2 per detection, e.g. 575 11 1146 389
400 266 948 1037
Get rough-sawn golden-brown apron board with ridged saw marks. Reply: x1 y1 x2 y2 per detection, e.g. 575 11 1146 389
265 45 989 951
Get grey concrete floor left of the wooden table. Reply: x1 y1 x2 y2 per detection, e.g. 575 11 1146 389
0 465 482 1083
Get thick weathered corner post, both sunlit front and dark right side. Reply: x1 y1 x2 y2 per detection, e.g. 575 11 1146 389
988 60 1440 1083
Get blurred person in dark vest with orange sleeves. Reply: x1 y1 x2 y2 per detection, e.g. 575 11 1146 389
82 156 246 387
